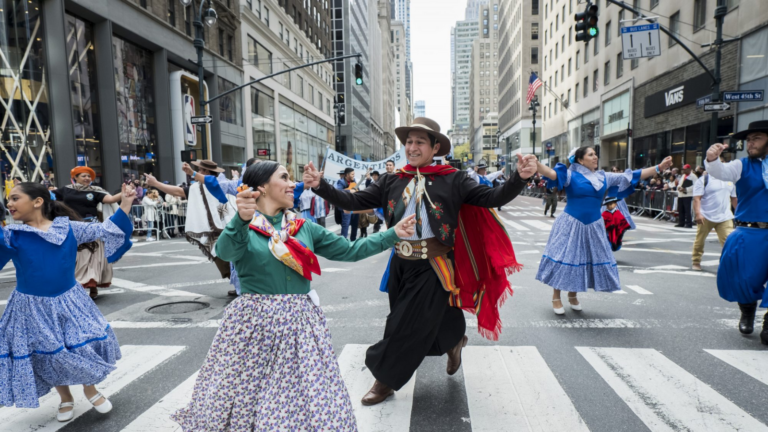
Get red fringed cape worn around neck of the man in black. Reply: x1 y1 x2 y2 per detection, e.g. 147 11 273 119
396 164 523 340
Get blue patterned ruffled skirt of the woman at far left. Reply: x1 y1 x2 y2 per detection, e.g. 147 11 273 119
0 283 120 408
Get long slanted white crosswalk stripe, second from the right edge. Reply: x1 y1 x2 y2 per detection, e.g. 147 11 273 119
576 347 768 432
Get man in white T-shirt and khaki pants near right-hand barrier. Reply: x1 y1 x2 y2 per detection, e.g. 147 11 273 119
692 163 736 270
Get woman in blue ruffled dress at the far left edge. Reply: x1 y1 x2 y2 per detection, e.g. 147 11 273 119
0 183 136 421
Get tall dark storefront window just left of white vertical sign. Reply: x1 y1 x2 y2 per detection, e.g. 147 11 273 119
112 36 157 179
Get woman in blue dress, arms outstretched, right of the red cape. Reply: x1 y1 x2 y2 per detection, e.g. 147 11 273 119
536 146 672 315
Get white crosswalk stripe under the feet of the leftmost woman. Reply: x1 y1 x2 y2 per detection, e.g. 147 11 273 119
0 345 186 432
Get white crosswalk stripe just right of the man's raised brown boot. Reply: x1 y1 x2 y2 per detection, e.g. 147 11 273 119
461 346 589 432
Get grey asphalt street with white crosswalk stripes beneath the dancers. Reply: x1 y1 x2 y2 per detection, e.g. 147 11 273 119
0 197 768 432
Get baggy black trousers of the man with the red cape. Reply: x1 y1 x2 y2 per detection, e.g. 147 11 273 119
365 255 467 390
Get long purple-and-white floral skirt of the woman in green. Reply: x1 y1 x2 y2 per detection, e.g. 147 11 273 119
171 294 357 432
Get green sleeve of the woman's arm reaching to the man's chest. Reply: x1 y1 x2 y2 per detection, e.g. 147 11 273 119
304 224 400 261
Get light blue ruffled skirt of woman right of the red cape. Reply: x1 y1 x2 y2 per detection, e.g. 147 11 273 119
536 213 621 292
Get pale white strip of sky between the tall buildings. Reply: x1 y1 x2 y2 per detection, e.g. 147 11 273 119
411 0 467 132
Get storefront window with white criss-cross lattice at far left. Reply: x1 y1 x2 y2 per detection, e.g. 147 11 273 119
0 0 53 182
